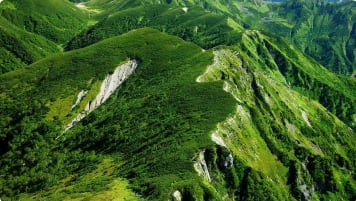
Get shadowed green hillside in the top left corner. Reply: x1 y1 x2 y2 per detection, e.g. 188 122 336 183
0 0 88 73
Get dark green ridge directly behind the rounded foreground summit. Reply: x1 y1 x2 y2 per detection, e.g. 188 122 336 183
66 1 242 50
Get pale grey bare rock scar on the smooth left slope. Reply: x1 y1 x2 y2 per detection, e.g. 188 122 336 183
62 60 139 133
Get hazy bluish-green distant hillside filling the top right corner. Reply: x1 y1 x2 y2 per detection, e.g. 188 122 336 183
276 1 356 73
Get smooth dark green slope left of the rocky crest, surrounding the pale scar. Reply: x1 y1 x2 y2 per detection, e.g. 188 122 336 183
0 29 233 198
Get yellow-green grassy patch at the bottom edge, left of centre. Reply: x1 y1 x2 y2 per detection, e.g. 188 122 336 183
19 159 141 201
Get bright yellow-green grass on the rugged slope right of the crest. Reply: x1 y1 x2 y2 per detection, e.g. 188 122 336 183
199 43 356 200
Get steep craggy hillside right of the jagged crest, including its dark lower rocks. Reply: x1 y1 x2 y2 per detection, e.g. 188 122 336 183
198 31 355 200
